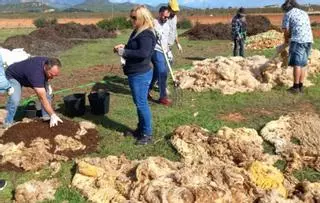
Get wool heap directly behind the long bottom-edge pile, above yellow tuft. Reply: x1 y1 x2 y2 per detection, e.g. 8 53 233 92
171 126 266 166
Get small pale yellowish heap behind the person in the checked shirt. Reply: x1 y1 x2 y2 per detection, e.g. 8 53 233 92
246 30 283 50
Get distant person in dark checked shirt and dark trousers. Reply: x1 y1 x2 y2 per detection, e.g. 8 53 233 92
231 7 247 57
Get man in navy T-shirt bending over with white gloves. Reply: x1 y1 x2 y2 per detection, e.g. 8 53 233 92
4 57 62 127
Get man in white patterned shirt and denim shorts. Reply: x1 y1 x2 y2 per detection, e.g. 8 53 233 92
281 0 313 93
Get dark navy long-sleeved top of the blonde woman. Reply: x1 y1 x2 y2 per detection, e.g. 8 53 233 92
123 30 156 75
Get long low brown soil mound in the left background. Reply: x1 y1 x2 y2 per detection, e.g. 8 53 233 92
1 23 116 56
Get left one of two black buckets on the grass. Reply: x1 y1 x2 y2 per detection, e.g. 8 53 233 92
63 93 86 117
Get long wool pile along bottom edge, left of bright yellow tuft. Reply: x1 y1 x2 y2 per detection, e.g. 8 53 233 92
72 156 256 203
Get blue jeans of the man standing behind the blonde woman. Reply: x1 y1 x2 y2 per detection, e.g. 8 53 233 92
149 51 168 99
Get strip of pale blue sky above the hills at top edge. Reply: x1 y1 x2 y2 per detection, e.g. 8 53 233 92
110 0 320 8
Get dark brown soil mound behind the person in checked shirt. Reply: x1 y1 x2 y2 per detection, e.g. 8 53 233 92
182 16 274 40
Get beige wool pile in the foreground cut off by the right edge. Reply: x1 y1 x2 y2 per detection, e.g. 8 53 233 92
261 113 320 171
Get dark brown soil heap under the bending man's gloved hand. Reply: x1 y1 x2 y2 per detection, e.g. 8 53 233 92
0 119 99 171
